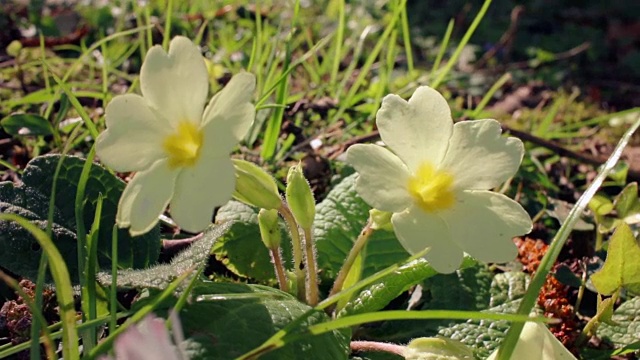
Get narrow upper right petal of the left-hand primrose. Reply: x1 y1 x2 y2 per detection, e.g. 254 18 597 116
202 72 256 153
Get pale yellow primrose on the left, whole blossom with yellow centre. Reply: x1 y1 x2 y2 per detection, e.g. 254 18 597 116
96 37 255 235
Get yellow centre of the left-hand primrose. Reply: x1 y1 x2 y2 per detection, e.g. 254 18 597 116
162 120 203 168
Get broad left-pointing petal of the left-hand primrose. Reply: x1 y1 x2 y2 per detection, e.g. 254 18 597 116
96 94 170 172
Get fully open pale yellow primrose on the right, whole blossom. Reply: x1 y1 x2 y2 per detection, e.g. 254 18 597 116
347 86 532 273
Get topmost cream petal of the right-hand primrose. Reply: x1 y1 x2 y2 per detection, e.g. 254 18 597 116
376 86 453 171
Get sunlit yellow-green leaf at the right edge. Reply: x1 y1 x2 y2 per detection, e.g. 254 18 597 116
591 222 640 295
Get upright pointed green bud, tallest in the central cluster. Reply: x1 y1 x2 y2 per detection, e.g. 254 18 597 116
285 163 316 229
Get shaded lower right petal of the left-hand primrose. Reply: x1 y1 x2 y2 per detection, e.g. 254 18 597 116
170 157 236 233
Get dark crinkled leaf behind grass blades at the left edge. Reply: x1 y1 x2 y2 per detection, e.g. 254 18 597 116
0 155 161 280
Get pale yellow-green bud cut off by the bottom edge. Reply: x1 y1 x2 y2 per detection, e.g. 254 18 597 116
403 337 475 360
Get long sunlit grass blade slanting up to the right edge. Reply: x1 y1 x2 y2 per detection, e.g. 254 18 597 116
498 117 640 360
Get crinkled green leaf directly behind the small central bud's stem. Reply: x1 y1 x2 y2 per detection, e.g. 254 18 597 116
211 201 291 282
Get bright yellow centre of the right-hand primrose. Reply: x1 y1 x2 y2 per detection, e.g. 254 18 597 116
408 162 456 212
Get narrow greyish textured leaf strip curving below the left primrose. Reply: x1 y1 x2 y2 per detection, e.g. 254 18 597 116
96 222 232 290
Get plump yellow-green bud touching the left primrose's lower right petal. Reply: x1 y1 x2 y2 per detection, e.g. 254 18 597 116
233 159 282 209
